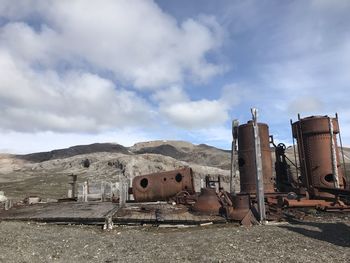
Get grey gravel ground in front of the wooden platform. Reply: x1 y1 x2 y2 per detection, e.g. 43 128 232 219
0 218 350 262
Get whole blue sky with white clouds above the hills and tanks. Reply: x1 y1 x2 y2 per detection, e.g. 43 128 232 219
0 0 350 153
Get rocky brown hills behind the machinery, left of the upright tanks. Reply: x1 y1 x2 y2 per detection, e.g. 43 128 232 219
0 141 238 199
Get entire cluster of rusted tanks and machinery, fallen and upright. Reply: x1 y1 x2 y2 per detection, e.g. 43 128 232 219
128 112 350 225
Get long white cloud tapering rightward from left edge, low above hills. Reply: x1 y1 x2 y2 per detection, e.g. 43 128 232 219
0 49 153 132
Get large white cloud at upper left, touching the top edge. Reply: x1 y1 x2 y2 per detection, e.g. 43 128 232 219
0 0 223 89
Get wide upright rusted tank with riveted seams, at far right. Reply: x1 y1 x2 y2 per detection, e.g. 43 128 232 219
292 116 345 197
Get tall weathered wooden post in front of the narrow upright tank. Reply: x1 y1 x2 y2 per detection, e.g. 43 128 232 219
251 108 266 224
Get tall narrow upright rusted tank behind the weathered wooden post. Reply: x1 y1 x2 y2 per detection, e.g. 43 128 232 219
238 121 275 194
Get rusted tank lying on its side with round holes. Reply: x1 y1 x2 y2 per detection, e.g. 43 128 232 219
132 168 194 202
